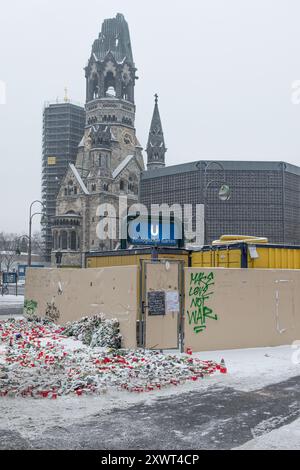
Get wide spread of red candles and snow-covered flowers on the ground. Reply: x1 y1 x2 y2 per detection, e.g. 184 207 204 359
0 320 222 398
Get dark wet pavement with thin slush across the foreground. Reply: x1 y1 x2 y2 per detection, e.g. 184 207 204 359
0 376 300 450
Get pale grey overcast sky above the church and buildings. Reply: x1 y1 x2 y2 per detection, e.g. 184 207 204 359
0 0 300 233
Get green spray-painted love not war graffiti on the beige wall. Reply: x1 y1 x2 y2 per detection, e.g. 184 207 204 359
187 272 218 334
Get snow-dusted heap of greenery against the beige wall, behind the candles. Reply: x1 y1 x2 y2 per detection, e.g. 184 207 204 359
64 313 122 349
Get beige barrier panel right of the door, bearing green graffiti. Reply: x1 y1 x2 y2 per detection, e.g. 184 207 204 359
184 268 300 351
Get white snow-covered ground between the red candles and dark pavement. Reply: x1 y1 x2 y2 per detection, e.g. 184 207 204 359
0 339 300 448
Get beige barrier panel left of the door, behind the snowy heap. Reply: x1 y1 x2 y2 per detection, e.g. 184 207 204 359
25 266 138 348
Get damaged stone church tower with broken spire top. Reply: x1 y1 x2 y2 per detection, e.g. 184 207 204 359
52 14 144 266
